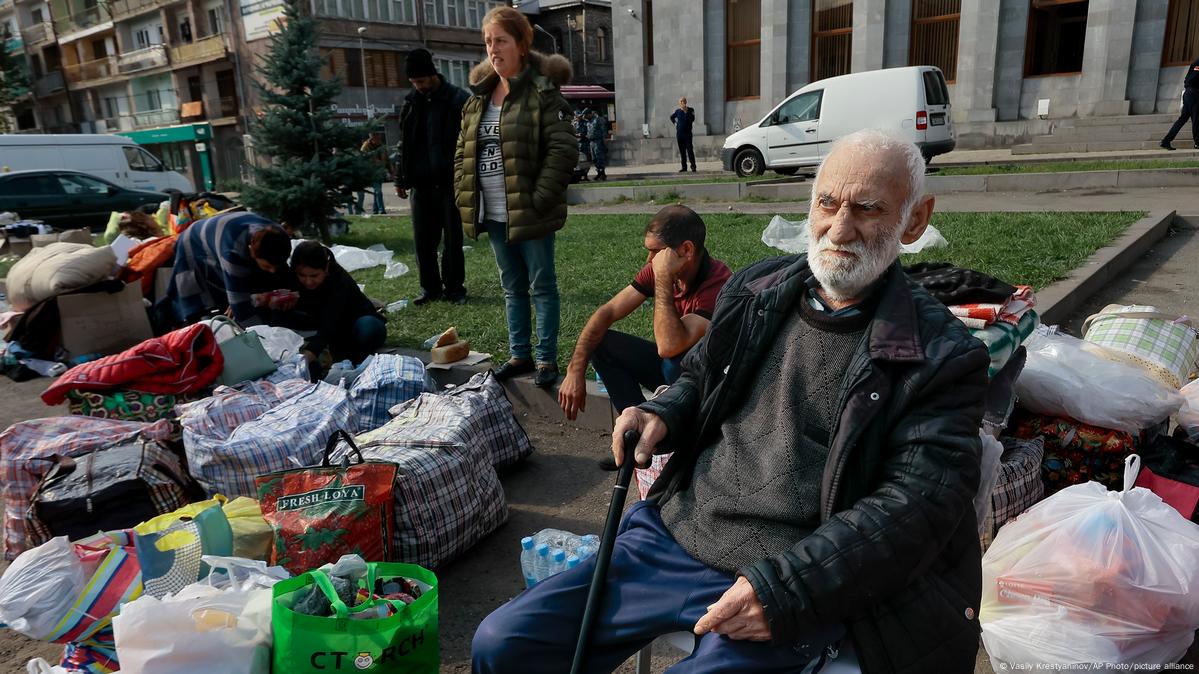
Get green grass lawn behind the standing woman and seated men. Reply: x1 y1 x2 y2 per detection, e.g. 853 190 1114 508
338 209 1144 367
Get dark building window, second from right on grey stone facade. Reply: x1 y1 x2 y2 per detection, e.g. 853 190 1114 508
1024 0 1090 77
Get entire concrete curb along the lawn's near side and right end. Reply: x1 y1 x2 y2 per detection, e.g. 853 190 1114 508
407 211 1175 432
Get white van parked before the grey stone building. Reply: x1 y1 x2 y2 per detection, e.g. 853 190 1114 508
721 66 954 177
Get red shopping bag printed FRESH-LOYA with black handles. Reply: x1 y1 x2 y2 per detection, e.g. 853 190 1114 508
255 431 397 574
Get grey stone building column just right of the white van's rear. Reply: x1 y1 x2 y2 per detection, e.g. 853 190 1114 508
952 0 999 122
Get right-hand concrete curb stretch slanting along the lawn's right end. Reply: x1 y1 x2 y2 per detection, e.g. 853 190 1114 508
1037 211 1175 325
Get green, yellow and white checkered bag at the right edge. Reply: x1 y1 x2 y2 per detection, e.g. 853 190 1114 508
1083 305 1199 389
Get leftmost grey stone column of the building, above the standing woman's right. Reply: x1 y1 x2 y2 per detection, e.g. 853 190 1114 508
611 0 646 142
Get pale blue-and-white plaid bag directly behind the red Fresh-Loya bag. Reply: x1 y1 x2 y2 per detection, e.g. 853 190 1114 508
179 380 355 498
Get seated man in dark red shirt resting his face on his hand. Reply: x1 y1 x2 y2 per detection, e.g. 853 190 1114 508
558 205 731 470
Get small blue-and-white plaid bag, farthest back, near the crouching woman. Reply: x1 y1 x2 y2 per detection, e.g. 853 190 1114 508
350 354 438 431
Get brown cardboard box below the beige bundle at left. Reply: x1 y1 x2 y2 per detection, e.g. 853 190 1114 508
58 283 153 356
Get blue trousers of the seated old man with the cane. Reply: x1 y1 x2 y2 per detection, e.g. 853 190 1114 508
471 501 844 674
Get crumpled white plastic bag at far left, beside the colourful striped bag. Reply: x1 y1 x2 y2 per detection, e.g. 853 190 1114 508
0 536 88 639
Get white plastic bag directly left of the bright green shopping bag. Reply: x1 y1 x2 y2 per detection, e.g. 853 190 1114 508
113 556 288 674
